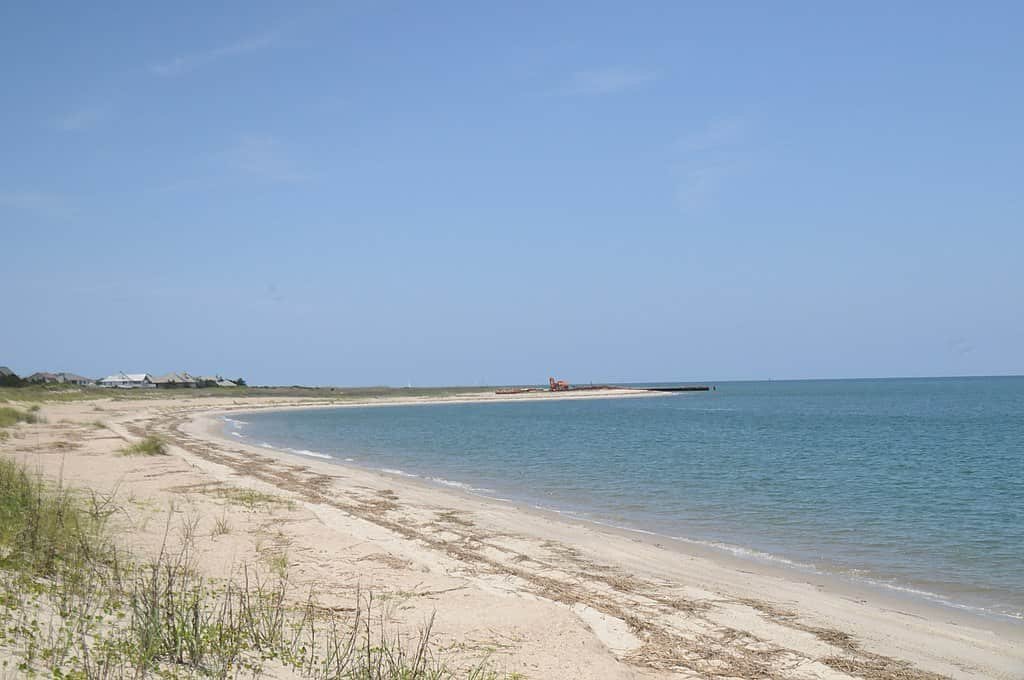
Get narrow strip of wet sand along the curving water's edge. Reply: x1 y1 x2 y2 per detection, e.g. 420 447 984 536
196 403 1024 632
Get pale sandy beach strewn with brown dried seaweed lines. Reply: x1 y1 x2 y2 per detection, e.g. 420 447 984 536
0 392 1024 680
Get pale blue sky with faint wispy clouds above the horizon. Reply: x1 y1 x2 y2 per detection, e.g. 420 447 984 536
0 2 1024 385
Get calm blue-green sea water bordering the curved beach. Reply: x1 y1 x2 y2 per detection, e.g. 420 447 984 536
227 378 1024 619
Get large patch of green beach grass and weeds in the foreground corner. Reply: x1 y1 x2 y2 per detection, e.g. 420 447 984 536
0 460 516 680
